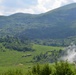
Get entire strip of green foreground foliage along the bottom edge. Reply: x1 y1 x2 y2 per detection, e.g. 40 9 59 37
0 61 76 75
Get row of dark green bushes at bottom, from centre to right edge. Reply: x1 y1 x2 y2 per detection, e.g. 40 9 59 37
28 62 76 75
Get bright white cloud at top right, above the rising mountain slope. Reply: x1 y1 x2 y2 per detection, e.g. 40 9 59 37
35 0 76 12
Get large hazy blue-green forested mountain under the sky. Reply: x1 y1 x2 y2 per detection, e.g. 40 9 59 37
0 3 76 39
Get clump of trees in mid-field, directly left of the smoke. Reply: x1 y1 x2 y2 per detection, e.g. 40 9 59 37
33 49 66 63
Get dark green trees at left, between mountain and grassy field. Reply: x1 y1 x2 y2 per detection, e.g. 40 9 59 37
0 36 33 51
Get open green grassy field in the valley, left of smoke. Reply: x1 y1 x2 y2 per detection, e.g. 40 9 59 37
0 45 63 73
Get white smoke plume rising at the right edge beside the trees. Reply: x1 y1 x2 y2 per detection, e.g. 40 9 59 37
61 43 76 63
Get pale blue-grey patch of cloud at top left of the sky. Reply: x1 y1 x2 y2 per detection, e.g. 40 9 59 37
2 0 37 8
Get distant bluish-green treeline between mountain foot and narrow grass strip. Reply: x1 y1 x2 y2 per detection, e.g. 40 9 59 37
33 36 76 47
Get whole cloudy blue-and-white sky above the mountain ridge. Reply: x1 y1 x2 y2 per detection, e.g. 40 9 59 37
0 0 76 15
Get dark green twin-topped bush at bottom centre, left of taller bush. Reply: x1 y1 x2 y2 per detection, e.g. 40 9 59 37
32 64 52 75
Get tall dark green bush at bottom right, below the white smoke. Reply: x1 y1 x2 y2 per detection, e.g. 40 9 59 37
53 61 75 75
